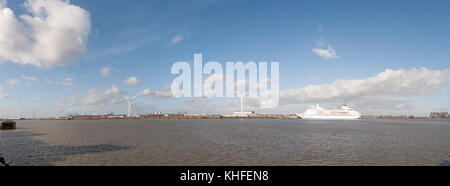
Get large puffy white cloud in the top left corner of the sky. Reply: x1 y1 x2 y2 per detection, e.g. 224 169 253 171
0 0 91 68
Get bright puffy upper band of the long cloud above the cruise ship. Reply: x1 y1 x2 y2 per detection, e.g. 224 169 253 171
280 68 450 104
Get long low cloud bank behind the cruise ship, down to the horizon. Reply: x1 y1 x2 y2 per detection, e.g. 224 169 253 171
179 68 450 115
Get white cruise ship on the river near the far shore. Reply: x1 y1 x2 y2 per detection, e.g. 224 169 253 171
297 105 361 120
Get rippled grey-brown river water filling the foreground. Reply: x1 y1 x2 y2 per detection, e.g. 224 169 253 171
0 120 450 165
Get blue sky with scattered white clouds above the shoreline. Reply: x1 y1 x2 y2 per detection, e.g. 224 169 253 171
0 0 450 118
